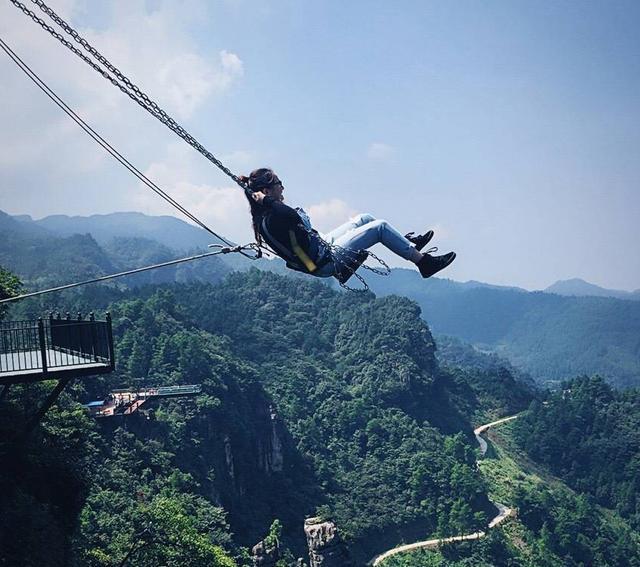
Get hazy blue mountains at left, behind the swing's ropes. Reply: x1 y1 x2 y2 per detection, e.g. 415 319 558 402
0 211 286 289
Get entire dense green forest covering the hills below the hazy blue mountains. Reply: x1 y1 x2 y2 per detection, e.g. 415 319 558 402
0 254 640 567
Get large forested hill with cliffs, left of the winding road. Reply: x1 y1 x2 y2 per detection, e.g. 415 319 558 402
0 270 532 565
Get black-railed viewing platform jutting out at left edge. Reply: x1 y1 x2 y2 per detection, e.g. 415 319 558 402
0 314 115 386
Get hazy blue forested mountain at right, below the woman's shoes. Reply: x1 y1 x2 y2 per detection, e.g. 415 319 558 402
370 270 640 387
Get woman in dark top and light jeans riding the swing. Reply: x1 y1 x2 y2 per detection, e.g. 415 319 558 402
241 168 456 283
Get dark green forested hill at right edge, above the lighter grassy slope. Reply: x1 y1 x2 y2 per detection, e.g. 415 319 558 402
515 377 640 529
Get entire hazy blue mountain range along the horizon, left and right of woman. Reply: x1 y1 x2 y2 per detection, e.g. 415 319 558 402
0 209 640 387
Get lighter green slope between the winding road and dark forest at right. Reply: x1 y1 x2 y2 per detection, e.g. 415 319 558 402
381 412 640 567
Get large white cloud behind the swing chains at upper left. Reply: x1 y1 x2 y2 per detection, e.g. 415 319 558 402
0 0 243 180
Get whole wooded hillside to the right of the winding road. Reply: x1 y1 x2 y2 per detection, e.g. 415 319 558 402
384 377 640 567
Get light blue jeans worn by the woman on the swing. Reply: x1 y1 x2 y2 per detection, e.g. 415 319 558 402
323 213 422 262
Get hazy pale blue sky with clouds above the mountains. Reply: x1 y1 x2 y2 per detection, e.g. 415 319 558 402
0 0 640 289
